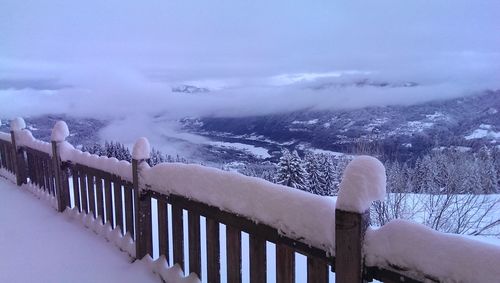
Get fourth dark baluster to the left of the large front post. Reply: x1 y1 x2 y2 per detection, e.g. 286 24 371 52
226 226 241 282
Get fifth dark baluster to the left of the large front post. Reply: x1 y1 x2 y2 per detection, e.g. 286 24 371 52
206 218 220 283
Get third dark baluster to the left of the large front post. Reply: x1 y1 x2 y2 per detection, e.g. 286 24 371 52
249 234 267 283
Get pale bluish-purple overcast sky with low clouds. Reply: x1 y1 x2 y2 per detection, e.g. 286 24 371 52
0 0 500 118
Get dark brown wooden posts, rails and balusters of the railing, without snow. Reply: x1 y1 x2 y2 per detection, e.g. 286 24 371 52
0 118 498 282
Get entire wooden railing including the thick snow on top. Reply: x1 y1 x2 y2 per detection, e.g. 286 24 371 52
0 119 500 282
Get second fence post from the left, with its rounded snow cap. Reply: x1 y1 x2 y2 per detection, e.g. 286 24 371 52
51 121 70 212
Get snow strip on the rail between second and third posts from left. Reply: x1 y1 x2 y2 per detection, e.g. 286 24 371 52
59 141 132 181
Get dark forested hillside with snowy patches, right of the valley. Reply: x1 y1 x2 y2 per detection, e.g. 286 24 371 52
181 91 500 163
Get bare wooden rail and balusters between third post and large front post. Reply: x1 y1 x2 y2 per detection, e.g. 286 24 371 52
145 189 334 282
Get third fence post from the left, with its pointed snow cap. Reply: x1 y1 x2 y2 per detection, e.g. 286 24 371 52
132 138 153 259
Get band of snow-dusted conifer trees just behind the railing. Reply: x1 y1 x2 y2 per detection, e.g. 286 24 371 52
82 141 500 196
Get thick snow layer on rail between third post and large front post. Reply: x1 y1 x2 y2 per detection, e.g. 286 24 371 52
139 163 335 254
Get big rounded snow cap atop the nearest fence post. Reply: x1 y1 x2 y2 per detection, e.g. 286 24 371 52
337 155 386 213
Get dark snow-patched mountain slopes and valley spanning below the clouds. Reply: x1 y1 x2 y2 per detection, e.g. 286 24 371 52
0 89 500 163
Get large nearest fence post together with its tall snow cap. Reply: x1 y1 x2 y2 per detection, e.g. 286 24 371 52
335 156 386 283
